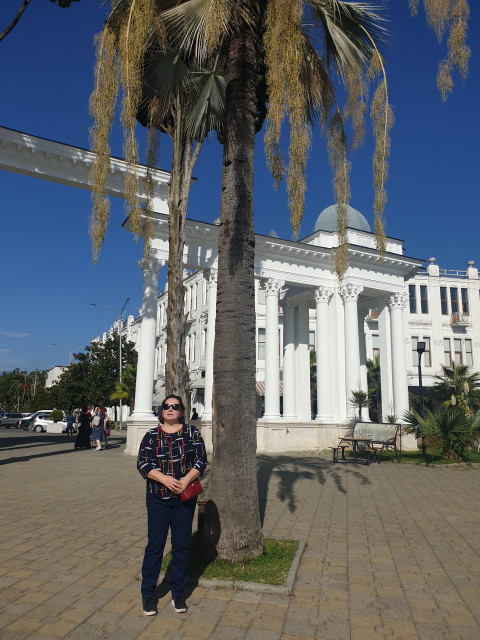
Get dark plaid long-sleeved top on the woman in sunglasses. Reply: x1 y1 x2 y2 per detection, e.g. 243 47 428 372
137 424 207 499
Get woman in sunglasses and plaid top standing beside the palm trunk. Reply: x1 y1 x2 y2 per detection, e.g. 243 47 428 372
137 395 207 616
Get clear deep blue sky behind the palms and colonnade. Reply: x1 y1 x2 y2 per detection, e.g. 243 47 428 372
0 0 480 371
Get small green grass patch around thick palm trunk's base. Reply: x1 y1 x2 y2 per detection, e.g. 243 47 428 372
162 531 298 585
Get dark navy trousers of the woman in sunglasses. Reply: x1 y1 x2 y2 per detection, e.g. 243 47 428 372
142 491 197 598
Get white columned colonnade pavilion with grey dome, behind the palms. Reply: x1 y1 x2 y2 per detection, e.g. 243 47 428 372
126 209 422 453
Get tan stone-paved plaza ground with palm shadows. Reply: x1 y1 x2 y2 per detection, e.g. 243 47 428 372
0 429 480 640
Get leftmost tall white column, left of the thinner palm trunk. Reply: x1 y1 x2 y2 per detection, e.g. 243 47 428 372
131 257 165 422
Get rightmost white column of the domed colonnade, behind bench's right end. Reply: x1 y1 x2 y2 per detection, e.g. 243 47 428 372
390 292 408 419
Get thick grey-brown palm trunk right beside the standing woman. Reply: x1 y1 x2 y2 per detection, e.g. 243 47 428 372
203 22 263 560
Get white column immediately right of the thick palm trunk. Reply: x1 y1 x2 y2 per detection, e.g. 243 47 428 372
262 278 285 420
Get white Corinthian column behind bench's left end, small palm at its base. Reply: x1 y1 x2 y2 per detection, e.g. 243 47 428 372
340 284 363 416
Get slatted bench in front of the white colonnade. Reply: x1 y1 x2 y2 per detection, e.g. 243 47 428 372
330 422 401 465
